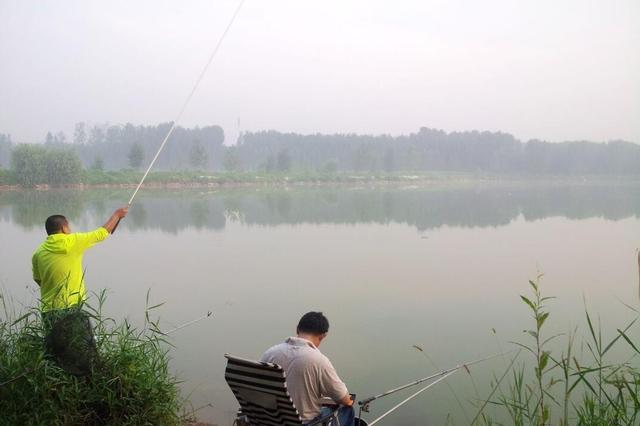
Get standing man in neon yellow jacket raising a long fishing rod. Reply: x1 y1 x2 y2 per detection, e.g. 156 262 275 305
31 207 128 374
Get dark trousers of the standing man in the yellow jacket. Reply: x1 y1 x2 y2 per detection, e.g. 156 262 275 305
42 308 98 376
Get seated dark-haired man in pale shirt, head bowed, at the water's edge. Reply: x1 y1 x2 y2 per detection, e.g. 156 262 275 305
260 312 355 426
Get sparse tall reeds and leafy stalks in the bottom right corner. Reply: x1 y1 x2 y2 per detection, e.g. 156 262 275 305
472 277 640 426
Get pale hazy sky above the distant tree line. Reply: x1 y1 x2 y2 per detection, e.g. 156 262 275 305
0 0 640 143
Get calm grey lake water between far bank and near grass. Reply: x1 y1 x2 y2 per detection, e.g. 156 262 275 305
0 184 640 426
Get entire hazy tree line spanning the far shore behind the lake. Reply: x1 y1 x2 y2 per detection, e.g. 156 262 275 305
0 123 640 176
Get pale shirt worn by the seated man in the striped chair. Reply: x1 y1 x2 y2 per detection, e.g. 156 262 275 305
260 337 348 422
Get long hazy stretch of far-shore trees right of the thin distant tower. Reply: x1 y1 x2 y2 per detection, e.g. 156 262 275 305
235 127 640 175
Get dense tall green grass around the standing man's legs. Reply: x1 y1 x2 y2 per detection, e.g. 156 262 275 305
0 292 186 425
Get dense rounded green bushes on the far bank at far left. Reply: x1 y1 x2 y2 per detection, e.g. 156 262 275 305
11 144 82 187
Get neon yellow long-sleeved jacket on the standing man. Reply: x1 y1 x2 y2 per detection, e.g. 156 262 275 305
31 227 109 311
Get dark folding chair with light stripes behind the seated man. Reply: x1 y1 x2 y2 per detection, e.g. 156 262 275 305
224 354 333 426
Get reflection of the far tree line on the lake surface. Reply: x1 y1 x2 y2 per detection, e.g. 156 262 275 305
0 184 640 233
